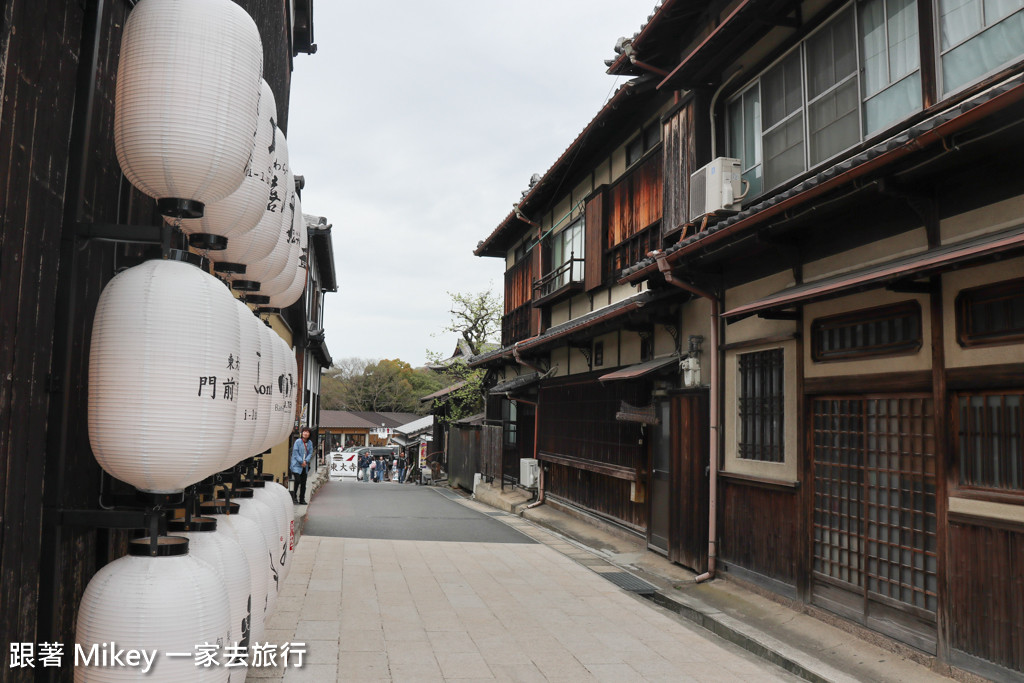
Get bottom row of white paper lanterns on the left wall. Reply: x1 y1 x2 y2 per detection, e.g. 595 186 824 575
75 482 294 683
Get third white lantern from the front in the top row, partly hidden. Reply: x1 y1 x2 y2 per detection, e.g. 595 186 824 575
210 128 295 280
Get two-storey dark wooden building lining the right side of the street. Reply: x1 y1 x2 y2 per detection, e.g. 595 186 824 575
474 0 1024 680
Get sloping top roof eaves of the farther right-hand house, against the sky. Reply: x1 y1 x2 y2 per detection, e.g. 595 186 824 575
473 77 667 256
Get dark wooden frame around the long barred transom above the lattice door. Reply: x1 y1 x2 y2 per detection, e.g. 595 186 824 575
811 299 924 362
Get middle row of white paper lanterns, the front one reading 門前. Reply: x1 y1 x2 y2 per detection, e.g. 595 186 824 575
89 260 298 494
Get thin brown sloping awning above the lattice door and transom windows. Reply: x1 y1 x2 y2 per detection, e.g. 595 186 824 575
720 225 1024 321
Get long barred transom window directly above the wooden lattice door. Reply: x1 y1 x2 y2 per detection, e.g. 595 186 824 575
811 301 921 361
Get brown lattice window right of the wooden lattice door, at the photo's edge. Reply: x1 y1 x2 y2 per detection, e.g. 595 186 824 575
955 391 1024 493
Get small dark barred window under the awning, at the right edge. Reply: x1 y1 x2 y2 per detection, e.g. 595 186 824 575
956 278 1024 346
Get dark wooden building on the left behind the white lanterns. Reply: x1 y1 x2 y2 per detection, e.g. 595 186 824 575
0 0 315 681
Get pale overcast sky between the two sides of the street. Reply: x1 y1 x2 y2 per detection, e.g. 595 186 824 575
288 0 655 367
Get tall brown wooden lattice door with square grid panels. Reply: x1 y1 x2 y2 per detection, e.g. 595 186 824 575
812 394 938 651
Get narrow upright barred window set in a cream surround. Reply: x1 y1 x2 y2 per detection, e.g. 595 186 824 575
737 348 785 463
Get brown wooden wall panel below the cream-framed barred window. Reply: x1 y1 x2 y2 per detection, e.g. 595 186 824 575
719 479 802 586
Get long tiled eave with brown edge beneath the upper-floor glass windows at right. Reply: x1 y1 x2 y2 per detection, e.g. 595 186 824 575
618 74 1024 284
